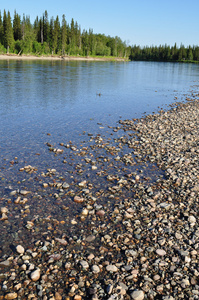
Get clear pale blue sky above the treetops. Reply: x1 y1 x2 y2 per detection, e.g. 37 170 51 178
0 0 199 46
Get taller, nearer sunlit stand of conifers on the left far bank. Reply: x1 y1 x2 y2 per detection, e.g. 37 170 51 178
0 10 131 57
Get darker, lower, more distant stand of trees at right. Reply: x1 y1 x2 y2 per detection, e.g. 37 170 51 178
130 44 199 61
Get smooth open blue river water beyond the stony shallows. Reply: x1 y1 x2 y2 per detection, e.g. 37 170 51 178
0 61 199 162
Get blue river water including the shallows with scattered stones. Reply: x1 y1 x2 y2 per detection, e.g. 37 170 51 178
0 61 199 252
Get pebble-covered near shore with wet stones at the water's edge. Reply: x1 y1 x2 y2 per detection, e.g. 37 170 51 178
0 93 199 300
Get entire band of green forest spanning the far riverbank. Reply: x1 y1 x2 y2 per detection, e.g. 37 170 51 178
0 10 199 62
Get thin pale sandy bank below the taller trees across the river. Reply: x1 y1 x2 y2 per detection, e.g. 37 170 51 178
0 54 127 61
